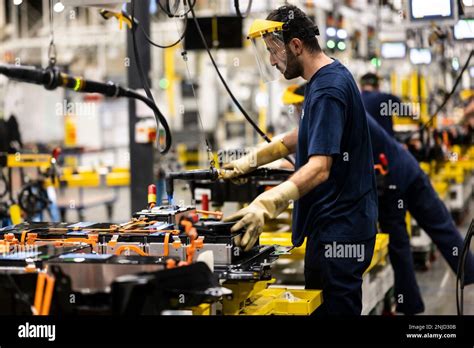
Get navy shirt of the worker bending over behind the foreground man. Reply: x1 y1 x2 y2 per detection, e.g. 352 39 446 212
367 114 421 192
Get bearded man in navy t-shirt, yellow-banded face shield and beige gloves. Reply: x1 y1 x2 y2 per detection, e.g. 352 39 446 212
221 5 377 315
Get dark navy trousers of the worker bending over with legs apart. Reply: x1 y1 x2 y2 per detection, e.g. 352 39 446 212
379 172 474 314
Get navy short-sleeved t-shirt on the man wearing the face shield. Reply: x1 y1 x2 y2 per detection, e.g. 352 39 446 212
293 61 377 246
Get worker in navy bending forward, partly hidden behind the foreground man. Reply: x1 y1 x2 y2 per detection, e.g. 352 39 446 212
284 85 474 314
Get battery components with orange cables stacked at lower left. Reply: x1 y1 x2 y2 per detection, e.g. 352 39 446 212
0 198 277 315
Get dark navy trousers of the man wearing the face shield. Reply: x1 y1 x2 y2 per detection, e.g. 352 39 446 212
305 233 375 316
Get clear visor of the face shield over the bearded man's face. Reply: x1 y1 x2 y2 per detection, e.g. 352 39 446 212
251 31 287 82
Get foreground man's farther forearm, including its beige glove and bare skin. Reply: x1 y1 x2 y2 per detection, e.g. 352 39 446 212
221 129 298 180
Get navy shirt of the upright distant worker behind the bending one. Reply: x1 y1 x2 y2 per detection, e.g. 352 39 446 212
361 91 402 136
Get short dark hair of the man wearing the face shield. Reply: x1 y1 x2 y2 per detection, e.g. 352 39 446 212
267 5 321 53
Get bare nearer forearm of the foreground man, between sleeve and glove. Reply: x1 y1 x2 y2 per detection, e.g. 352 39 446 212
290 156 332 197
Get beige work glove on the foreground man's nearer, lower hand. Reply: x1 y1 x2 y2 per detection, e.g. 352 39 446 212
224 181 300 251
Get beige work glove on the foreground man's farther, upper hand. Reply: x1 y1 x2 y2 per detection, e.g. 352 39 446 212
219 137 290 180
